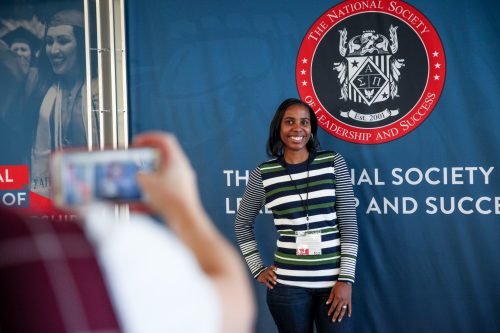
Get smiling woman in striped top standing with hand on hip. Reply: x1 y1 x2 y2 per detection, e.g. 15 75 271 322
235 98 358 333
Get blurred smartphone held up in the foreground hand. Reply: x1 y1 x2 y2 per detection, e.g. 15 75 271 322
50 148 159 207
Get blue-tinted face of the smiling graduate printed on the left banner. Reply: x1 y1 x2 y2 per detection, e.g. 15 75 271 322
45 25 78 75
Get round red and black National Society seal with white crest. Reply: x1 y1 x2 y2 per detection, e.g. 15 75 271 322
296 0 446 144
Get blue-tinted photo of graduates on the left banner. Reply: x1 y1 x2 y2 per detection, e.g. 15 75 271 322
0 1 99 197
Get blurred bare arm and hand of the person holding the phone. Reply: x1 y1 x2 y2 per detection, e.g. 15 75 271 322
135 133 254 332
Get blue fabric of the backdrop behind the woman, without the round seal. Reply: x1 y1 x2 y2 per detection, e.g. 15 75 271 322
126 0 500 332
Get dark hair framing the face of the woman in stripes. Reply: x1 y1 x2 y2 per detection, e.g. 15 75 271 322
267 98 320 157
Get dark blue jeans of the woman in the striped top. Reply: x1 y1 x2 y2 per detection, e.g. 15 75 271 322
267 284 354 333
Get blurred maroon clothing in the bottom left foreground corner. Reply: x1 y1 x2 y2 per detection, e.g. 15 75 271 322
0 208 120 333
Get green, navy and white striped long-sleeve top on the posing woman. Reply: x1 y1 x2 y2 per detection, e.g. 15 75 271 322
235 151 358 288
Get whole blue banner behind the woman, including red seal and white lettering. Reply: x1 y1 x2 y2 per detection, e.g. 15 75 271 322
130 0 500 332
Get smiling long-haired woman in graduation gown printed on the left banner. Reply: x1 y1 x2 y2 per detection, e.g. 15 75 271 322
28 10 98 196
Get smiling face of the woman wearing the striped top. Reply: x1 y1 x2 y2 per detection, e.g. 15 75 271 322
280 104 311 151
